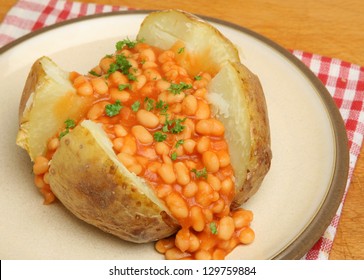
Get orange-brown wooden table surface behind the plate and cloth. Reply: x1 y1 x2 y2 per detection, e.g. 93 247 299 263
0 0 364 260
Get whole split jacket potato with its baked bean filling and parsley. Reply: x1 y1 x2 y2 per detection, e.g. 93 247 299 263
16 10 272 258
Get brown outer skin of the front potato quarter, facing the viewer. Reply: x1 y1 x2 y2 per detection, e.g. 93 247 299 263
49 125 178 243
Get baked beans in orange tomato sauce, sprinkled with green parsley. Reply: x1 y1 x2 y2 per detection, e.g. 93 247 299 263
34 40 254 259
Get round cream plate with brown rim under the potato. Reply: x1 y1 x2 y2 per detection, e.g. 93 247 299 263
0 11 348 259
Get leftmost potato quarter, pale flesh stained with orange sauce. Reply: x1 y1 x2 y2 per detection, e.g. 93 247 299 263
16 57 88 161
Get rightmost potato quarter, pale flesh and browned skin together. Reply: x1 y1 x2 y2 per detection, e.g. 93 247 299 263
208 63 272 207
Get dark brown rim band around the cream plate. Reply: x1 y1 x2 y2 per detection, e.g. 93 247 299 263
0 9 349 260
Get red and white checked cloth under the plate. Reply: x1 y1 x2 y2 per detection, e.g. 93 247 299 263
0 0 364 259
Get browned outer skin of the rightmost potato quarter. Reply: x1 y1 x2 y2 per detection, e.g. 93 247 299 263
232 63 272 208
